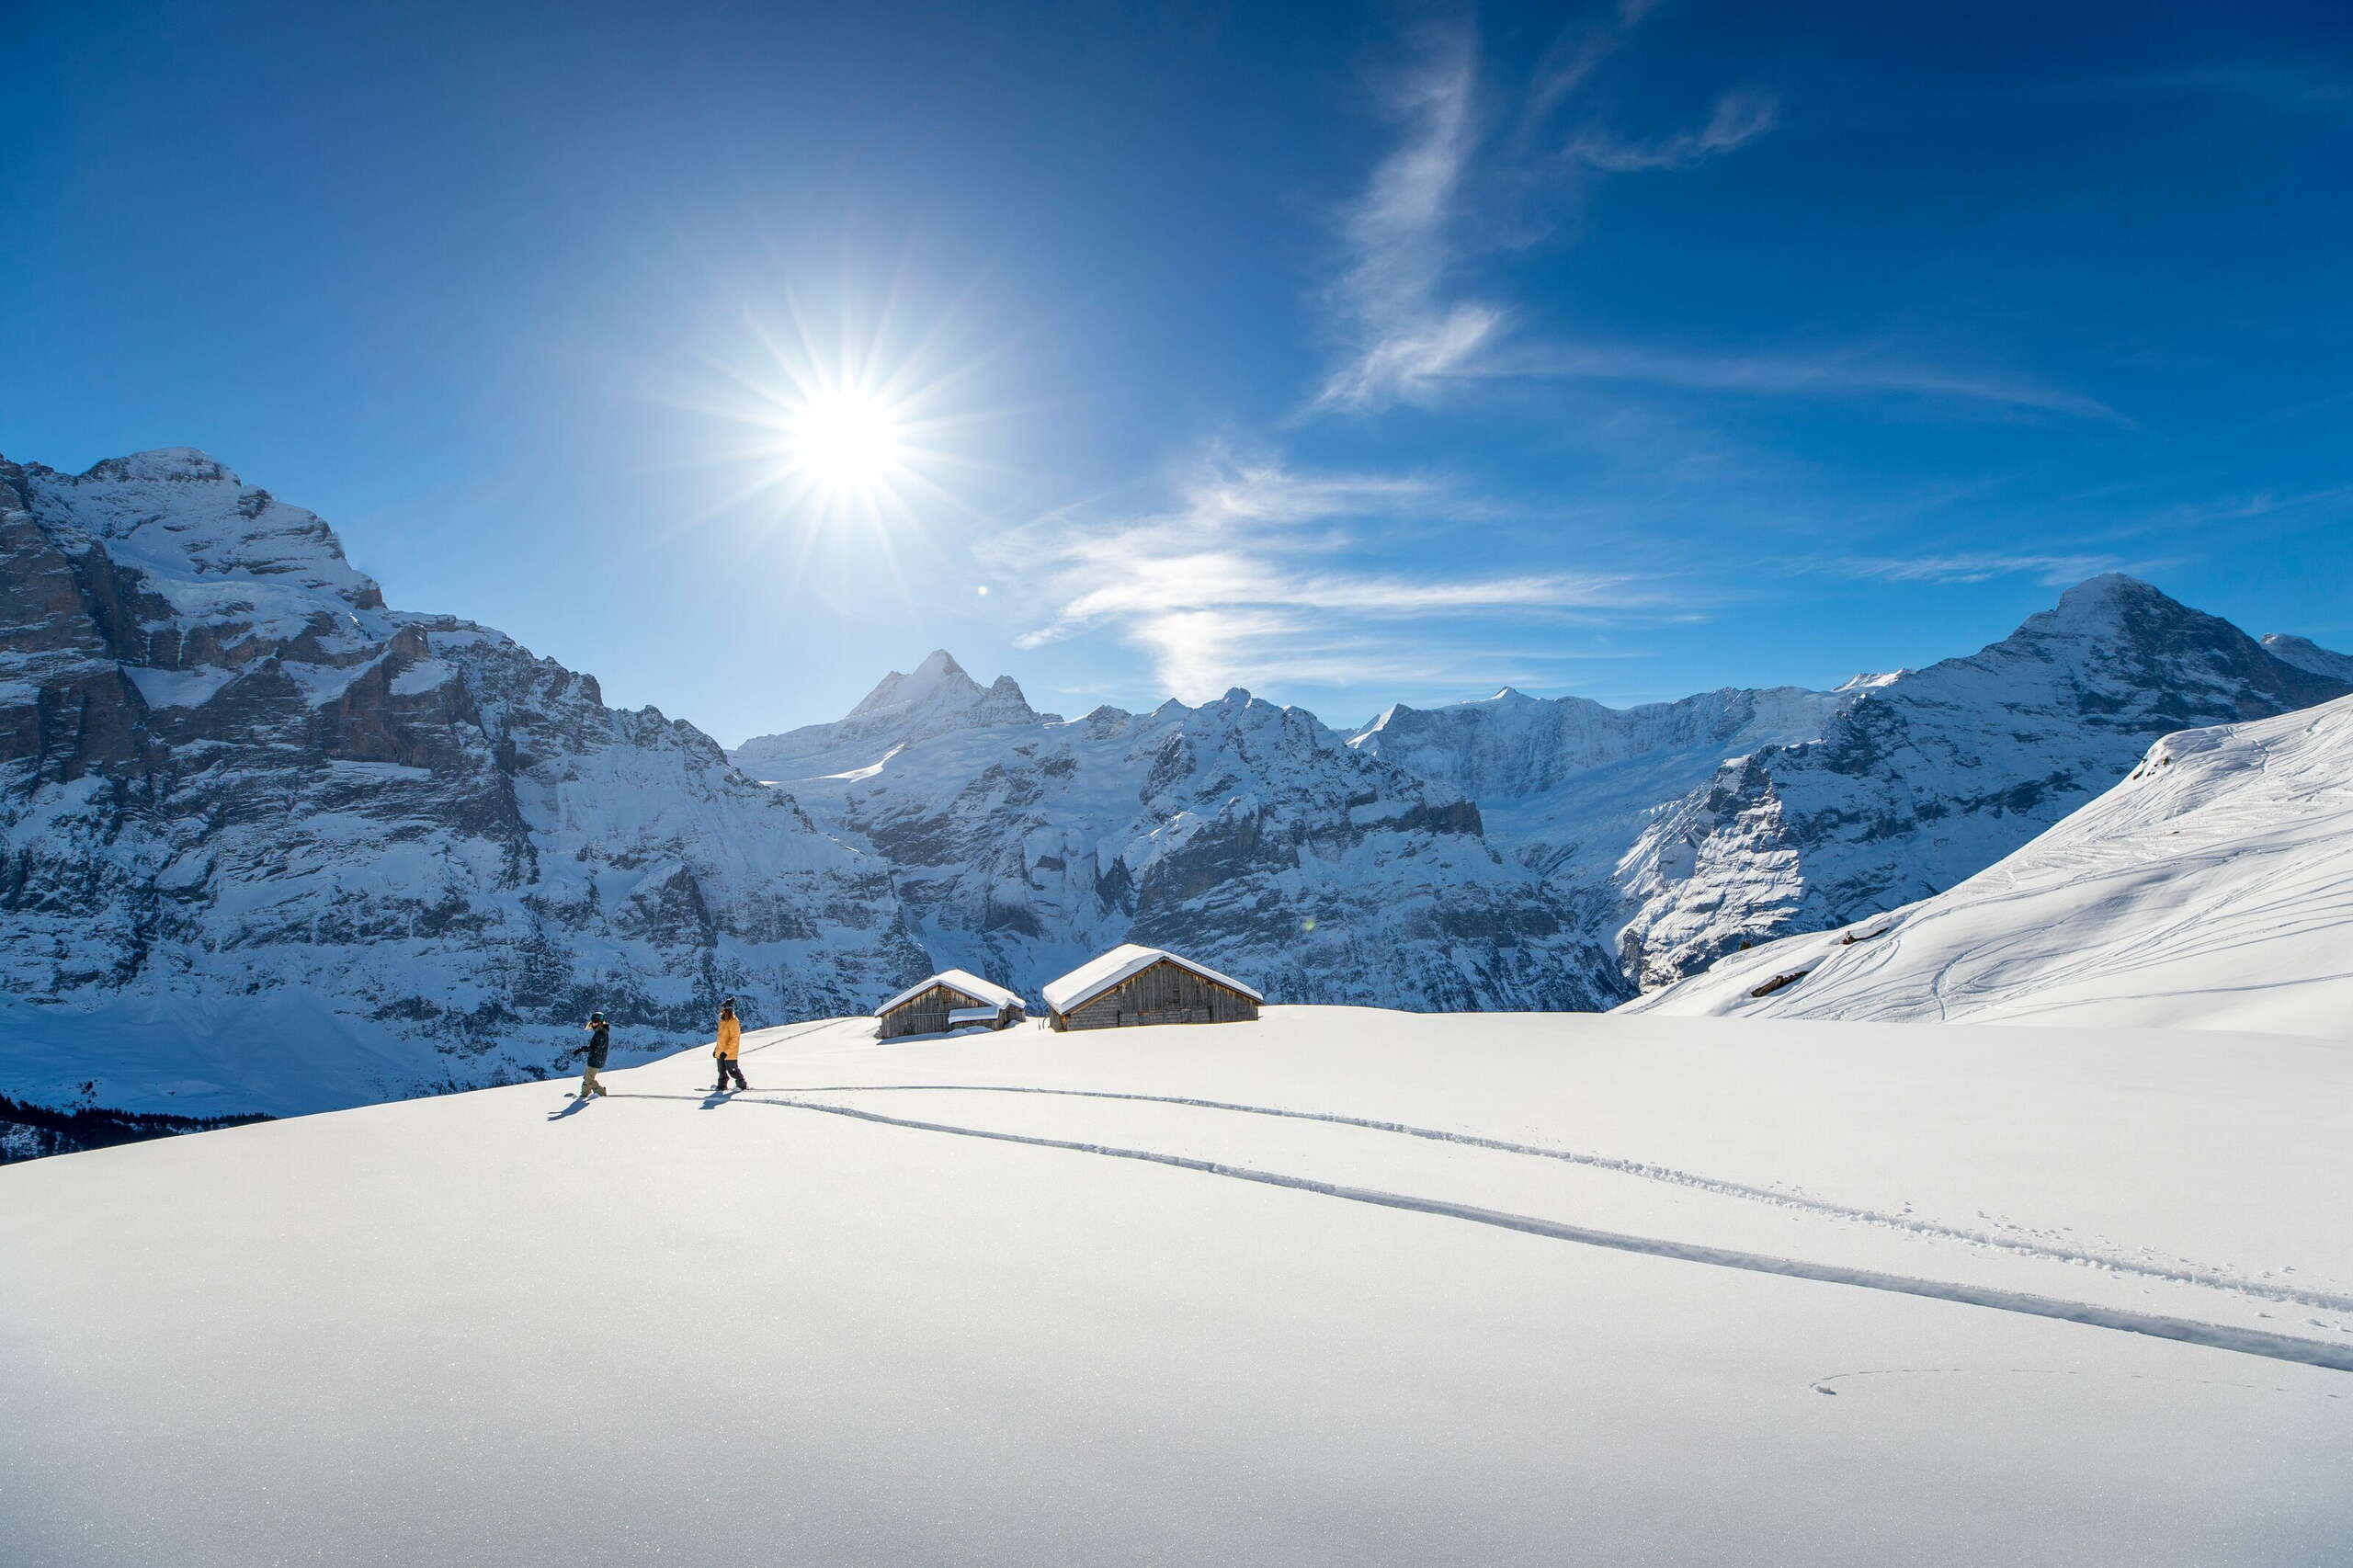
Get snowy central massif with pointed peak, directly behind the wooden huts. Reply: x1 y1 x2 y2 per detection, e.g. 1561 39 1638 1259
736 654 1619 1010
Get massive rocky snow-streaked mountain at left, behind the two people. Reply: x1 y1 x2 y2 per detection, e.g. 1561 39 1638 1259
0 448 925 1114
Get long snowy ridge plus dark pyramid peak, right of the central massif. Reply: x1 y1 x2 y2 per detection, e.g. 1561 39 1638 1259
1356 574 2353 986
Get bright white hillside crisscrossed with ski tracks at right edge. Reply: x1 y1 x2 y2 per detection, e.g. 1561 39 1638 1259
1626 697 2353 1040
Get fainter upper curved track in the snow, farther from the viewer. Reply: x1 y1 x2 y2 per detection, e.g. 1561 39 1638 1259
710 1083 2353 1312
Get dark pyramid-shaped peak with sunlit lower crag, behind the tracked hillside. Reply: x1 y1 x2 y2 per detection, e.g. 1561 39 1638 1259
1617 574 2353 986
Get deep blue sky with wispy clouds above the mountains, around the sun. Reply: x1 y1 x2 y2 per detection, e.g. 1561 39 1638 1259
0 0 2353 744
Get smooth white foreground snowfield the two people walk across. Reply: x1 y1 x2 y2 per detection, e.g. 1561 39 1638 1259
0 1007 2353 1568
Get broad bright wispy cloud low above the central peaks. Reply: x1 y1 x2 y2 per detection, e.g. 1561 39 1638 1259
993 449 1665 701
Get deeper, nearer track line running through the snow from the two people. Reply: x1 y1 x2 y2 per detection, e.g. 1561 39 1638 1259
631 1085 2353 1372
